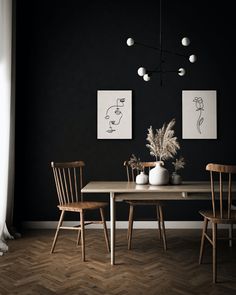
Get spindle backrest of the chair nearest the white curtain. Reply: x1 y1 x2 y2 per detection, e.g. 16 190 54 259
51 161 85 205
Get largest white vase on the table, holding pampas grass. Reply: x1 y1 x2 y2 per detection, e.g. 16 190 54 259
149 161 169 185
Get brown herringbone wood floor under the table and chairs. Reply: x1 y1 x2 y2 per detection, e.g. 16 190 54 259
0 229 236 295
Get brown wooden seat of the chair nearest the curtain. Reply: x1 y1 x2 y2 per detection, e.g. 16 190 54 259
57 202 108 212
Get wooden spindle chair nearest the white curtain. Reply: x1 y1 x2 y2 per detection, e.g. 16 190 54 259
51 161 110 261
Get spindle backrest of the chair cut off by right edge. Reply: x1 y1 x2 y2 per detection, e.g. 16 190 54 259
206 163 236 218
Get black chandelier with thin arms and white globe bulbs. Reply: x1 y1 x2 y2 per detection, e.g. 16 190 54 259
126 0 197 86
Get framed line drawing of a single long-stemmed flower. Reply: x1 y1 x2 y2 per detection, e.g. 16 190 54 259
182 90 217 139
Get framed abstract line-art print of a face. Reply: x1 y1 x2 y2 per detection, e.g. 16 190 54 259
97 90 132 139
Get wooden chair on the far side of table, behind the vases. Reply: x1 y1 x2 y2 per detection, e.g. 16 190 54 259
124 161 167 250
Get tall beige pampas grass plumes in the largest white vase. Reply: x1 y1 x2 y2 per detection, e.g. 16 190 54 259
146 119 180 161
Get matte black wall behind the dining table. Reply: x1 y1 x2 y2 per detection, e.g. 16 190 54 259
14 0 236 225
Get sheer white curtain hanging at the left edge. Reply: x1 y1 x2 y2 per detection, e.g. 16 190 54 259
0 0 13 255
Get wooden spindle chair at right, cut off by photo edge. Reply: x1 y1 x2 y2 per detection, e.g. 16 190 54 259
199 163 236 283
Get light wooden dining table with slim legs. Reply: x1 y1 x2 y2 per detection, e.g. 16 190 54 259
81 181 236 265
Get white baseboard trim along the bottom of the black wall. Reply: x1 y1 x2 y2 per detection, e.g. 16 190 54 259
23 221 232 229
